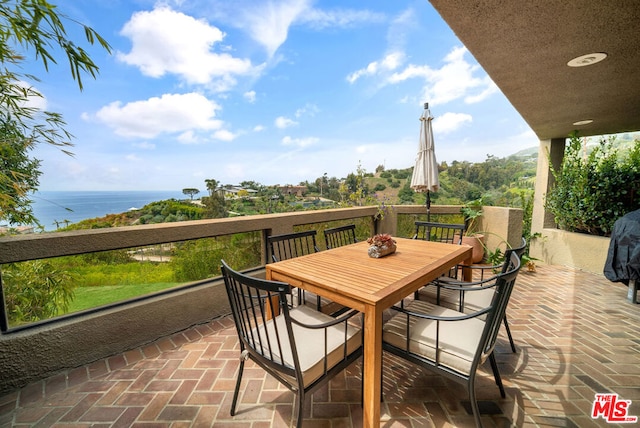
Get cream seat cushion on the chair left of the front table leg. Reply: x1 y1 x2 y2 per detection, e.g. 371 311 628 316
258 305 362 386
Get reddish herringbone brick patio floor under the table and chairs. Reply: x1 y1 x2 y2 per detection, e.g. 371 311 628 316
0 266 640 428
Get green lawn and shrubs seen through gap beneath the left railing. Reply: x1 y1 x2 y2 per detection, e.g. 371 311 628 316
2 232 262 326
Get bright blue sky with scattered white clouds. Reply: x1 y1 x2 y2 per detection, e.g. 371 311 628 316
31 0 538 190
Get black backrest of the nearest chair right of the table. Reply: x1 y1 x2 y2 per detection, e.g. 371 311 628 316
476 252 521 362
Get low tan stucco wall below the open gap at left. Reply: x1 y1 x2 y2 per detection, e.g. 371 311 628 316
0 276 232 394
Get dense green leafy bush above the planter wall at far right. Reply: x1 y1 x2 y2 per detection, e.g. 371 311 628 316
546 133 640 236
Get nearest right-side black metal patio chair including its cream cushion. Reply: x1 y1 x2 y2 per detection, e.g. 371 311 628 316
382 254 520 427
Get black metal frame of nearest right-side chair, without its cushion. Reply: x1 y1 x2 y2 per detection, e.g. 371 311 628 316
382 254 521 427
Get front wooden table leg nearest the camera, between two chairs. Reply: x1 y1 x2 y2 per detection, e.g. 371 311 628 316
362 307 382 428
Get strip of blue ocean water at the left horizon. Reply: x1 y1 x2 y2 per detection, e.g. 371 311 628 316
31 190 188 231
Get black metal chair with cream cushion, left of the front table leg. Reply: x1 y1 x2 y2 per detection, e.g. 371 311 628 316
221 261 362 428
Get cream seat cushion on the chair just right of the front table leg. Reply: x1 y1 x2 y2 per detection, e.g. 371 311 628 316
382 301 485 375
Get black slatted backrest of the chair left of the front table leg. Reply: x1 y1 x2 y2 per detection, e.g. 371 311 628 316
221 260 297 377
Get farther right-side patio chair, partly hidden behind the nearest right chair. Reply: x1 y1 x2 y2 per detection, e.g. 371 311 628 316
419 238 527 353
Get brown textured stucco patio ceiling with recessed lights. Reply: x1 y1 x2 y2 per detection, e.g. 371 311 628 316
430 0 640 140
